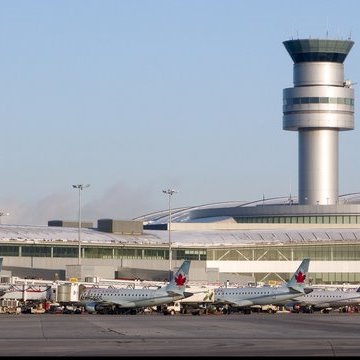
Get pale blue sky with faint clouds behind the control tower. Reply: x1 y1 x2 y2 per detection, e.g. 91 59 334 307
0 0 360 226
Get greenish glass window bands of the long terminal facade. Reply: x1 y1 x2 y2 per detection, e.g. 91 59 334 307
0 242 360 284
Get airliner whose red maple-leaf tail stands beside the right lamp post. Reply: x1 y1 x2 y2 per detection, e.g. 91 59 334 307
79 260 192 314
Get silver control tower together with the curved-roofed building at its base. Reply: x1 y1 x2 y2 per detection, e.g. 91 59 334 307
151 39 360 226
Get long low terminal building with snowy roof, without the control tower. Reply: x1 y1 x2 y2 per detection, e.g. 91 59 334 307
0 194 360 284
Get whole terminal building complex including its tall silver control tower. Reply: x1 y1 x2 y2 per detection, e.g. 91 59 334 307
0 39 360 284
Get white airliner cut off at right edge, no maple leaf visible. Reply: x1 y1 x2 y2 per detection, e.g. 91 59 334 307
285 287 360 313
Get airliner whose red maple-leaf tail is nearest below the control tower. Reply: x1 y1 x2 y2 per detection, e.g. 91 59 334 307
214 258 313 314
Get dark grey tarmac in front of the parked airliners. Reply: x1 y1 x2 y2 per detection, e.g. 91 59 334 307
0 312 360 357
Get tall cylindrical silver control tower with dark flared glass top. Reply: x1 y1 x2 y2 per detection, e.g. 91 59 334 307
283 39 354 205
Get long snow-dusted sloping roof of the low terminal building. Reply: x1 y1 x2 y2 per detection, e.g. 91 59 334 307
0 225 360 247
